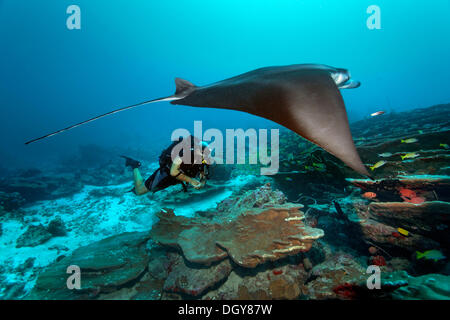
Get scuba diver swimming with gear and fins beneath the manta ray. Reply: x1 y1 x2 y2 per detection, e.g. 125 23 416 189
121 136 211 196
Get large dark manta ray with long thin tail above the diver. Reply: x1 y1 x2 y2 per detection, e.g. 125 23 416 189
26 64 370 177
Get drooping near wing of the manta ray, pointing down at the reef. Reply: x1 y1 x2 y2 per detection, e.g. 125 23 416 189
272 72 370 177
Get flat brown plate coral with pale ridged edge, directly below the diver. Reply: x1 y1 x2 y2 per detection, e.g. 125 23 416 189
151 204 323 268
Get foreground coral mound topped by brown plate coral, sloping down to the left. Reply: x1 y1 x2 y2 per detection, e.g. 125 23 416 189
26 185 324 299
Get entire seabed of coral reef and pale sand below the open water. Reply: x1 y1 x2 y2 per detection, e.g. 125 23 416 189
0 104 450 300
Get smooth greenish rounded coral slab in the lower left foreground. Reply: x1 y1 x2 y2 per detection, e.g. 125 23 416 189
27 232 150 299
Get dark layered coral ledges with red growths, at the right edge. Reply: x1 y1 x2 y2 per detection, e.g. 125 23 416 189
349 175 450 252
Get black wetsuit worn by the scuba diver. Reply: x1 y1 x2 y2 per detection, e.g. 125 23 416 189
145 141 207 193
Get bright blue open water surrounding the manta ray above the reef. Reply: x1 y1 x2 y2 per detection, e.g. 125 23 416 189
0 0 450 167
